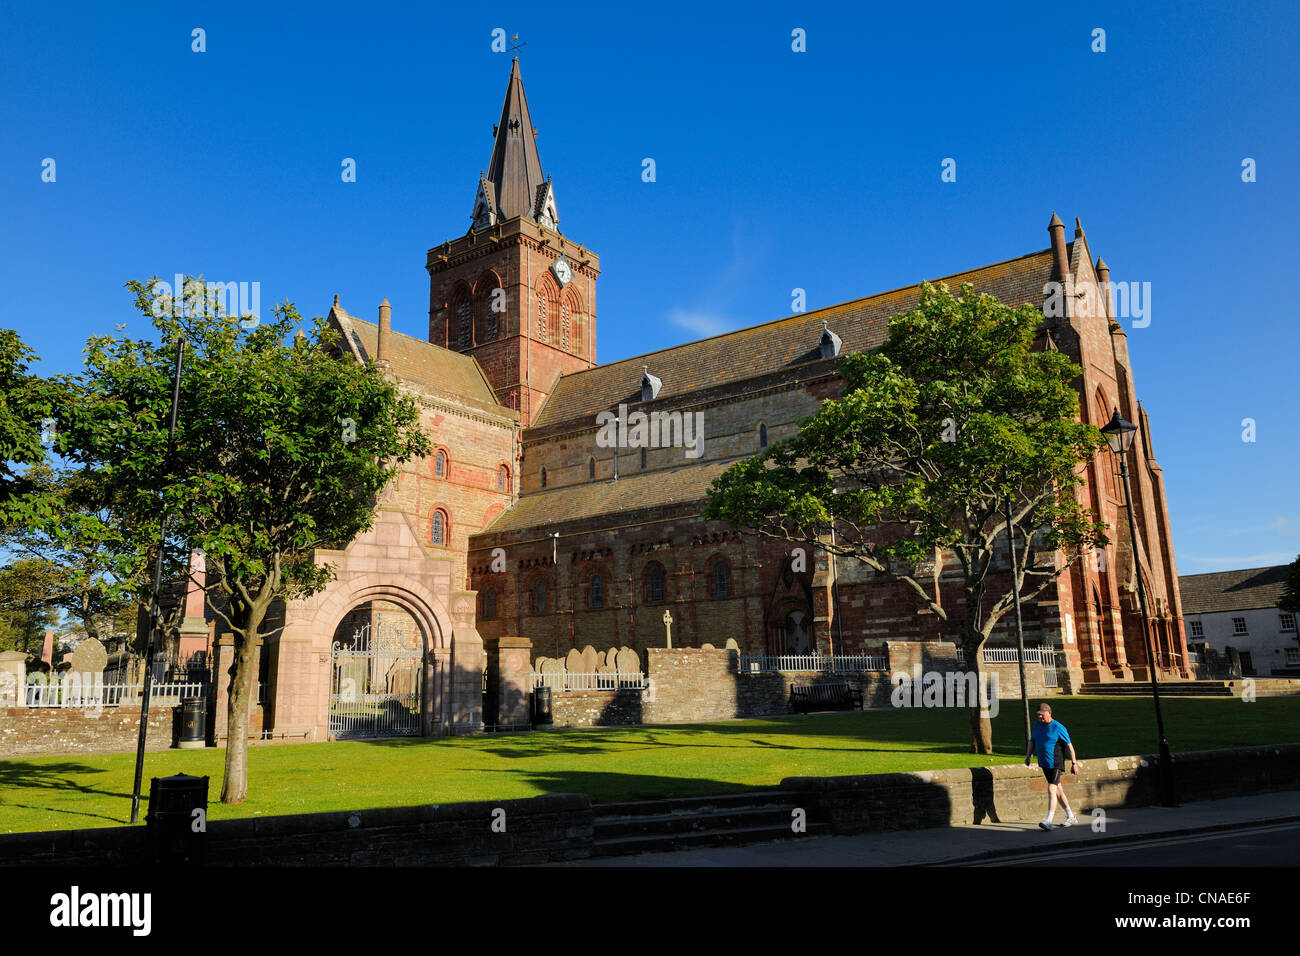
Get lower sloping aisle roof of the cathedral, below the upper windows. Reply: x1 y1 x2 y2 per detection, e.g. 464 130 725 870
480 458 740 535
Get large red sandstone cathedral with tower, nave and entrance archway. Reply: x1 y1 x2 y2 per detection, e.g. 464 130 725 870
241 60 1188 739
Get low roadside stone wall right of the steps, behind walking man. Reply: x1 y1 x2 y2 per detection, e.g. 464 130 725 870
781 744 1300 834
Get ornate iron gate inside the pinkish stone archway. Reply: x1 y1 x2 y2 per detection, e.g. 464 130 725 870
329 624 424 737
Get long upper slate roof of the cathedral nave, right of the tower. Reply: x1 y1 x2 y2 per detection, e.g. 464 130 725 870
534 243 1060 428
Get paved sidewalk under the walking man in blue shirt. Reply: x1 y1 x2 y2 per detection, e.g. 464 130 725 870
558 791 1300 866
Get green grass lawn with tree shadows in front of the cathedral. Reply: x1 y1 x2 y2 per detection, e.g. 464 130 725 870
0 697 1300 832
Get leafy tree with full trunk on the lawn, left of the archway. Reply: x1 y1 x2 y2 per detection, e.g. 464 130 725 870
59 277 430 804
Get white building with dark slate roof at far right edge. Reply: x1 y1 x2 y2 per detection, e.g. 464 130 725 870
1178 564 1300 678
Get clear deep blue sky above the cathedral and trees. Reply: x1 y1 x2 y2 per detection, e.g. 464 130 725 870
0 3 1300 574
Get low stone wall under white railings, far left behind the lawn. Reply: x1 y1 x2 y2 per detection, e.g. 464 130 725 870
0 704 174 758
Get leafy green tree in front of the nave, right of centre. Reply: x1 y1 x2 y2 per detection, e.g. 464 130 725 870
705 284 1106 753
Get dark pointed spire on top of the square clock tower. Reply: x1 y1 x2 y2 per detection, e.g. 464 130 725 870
473 57 559 229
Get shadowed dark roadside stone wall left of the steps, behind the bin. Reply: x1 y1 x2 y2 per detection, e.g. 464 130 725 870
0 793 593 866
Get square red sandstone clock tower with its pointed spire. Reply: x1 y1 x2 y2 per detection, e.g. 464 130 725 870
425 57 601 427
